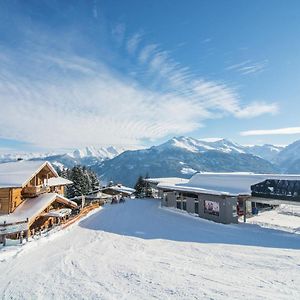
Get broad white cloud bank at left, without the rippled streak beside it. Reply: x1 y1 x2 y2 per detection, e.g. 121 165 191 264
0 51 208 148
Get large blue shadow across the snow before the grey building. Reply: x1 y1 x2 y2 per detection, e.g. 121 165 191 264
79 200 300 249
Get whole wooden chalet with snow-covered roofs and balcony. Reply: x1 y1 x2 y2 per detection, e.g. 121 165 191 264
0 161 77 242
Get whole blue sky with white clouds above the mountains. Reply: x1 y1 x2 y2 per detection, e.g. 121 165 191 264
0 0 300 152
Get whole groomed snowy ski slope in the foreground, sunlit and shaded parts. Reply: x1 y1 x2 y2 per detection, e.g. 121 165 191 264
0 200 300 300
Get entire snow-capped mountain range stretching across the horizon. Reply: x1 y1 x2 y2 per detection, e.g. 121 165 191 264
0 136 300 186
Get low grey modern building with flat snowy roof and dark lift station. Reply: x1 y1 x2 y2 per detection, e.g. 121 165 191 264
145 173 300 224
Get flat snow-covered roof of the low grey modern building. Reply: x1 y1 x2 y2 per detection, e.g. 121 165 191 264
157 172 300 196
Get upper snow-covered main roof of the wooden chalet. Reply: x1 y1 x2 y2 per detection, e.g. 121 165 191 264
0 160 58 188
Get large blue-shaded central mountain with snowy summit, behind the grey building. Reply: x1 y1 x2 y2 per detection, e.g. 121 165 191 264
92 137 282 186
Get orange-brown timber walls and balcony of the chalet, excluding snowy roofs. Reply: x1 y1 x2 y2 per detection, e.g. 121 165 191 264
0 163 77 240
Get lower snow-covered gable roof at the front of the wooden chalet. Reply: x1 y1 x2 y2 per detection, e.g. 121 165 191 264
0 193 77 224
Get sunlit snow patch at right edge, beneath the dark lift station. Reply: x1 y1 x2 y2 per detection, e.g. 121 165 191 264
247 204 300 234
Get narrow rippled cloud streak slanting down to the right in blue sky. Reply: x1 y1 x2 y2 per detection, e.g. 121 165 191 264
135 39 278 118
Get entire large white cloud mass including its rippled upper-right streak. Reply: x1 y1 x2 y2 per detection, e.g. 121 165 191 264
0 16 277 149
